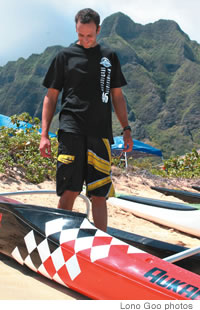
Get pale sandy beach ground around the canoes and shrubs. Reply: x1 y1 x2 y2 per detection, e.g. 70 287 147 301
0 168 200 300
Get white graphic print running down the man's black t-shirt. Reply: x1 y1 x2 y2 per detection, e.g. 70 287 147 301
100 57 112 103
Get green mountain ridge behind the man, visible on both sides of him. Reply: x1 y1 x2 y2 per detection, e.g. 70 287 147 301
0 12 200 157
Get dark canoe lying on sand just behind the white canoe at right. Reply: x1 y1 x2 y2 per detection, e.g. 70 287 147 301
151 186 200 203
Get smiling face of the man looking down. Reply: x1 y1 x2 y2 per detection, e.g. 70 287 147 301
76 21 100 48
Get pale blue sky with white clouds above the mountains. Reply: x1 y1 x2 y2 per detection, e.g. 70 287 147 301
0 0 200 66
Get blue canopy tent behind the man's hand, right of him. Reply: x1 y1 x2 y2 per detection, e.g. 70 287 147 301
111 136 162 157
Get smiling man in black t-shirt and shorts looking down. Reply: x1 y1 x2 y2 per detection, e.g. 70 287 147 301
40 9 133 231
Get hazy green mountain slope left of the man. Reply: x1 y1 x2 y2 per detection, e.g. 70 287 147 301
0 46 63 118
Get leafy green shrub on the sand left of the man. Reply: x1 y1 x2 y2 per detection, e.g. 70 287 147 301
0 113 57 183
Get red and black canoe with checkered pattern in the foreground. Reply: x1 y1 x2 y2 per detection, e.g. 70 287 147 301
0 197 200 300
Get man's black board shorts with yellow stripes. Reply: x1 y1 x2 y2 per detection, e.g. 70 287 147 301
56 131 115 198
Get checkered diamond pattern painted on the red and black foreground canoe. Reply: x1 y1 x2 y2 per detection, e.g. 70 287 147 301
12 217 144 286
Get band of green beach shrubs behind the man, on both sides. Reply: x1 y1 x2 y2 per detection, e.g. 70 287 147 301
0 113 200 184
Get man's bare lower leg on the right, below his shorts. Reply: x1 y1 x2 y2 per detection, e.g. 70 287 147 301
92 196 107 231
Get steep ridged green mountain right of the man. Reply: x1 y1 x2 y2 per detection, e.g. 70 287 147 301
100 13 200 156
